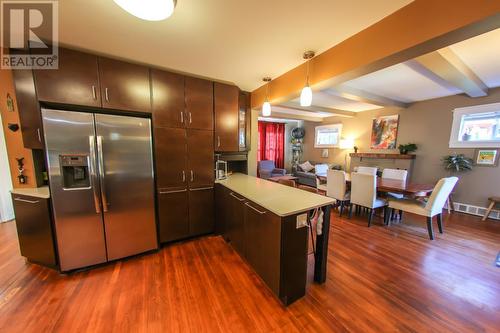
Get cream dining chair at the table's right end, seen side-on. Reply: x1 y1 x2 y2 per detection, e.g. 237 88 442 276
385 177 458 240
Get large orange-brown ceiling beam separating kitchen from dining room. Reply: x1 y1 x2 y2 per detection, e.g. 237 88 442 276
251 0 500 108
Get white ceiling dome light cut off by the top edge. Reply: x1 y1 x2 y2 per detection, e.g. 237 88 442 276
113 0 177 21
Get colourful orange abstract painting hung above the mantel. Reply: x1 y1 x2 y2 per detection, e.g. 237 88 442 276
370 115 399 149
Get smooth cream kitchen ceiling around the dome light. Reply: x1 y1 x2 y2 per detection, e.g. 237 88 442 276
55 0 411 91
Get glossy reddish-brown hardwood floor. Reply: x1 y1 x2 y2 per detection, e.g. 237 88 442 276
0 213 500 332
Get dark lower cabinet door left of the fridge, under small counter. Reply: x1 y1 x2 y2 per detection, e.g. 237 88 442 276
12 194 57 267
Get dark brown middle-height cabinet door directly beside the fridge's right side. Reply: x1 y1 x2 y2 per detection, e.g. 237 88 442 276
154 127 187 189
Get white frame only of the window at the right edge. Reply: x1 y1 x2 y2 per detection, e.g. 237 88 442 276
449 103 500 148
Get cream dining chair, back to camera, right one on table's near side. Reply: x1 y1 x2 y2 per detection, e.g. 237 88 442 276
349 172 387 227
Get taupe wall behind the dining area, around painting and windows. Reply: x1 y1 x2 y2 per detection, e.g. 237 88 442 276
303 88 500 207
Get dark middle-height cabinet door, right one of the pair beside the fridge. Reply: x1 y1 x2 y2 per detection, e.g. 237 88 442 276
187 130 214 188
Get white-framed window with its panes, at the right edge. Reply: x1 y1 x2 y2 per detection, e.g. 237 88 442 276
450 103 500 148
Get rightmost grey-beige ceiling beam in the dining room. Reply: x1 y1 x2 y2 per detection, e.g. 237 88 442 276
415 47 488 97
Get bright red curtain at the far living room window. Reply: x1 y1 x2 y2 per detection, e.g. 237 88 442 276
257 121 285 168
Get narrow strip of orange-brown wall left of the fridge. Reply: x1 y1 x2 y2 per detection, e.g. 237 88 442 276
0 70 36 187
